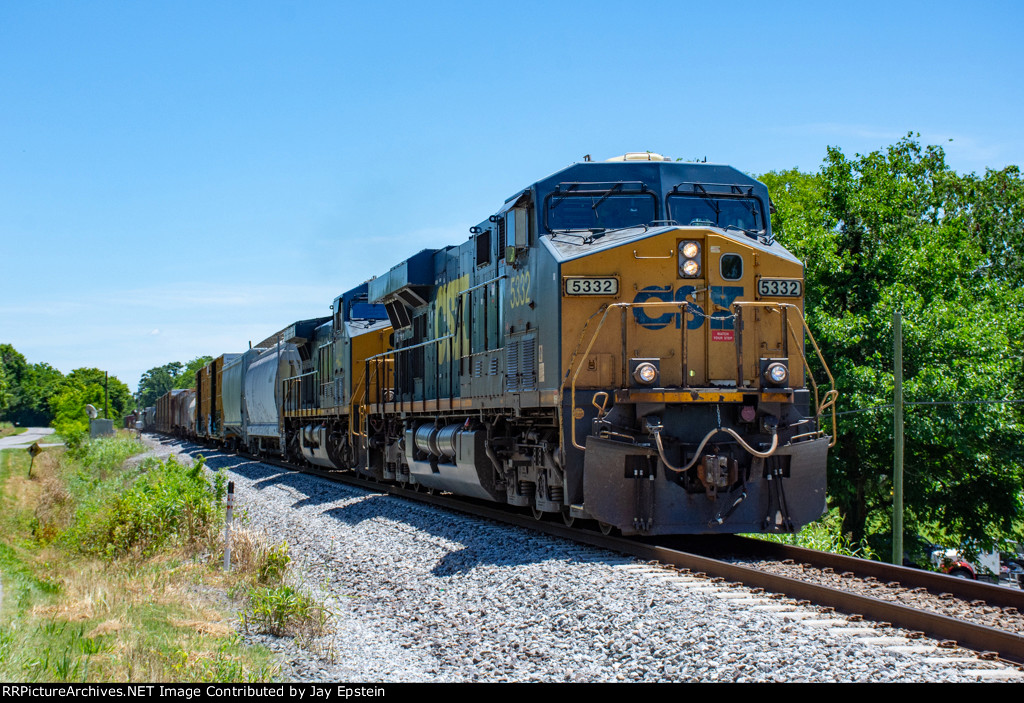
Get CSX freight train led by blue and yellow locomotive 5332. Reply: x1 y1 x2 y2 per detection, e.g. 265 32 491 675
163 153 836 534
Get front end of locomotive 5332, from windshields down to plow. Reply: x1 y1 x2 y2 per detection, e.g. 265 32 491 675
542 156 835 534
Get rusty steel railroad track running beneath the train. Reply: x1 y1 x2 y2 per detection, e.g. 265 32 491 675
169 433 1024 665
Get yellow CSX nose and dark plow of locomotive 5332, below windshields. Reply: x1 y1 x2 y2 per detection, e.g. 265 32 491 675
561 224 827 533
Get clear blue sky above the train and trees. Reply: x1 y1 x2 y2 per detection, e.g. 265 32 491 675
0 0 1024 397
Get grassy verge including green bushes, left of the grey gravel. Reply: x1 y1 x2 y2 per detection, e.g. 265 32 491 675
0 436 289 683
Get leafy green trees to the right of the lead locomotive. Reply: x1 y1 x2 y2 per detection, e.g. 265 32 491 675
762 135 1024 546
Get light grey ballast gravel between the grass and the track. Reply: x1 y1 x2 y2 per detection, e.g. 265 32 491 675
146 436 1015 683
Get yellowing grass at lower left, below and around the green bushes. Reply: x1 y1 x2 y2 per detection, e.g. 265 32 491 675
0 442 278 682
